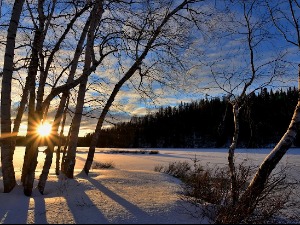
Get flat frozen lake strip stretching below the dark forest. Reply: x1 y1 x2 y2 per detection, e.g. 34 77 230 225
8 147 300 177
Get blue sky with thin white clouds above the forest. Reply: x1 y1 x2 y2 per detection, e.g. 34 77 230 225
0 0 300 136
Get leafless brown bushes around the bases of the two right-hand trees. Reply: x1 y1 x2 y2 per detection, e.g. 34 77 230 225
154 158 290 224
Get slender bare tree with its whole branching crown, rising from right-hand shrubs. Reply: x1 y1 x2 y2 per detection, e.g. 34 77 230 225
186 0 288 209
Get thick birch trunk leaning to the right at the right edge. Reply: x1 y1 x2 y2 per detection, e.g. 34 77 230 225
216 64 300 224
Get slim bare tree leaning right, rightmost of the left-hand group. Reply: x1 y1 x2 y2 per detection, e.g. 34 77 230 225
83 0 204 174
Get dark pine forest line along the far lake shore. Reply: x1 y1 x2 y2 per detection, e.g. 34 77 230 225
72 88 300 148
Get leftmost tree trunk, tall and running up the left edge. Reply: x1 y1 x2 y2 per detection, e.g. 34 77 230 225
1 0 24 193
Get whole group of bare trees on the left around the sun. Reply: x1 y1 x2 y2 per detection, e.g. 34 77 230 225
1 0 201 196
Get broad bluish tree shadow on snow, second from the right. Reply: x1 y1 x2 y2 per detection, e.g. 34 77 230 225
65 180 109 224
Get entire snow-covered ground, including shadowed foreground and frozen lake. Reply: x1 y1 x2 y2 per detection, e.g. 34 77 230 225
0 147 300 224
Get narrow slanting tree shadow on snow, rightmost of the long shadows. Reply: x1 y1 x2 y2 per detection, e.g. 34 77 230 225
87 177 151 223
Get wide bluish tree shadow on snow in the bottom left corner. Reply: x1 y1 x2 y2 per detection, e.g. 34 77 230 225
0 186 30 224
